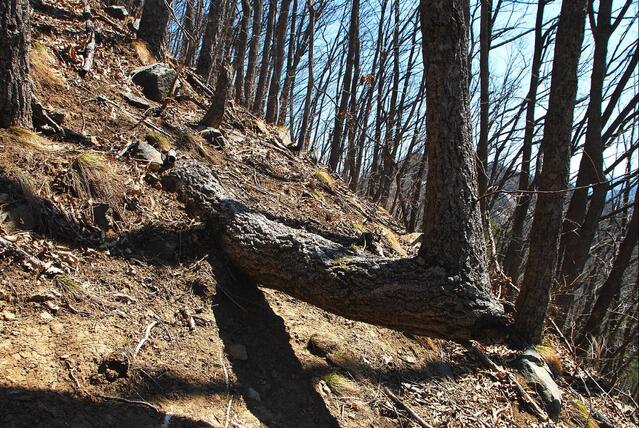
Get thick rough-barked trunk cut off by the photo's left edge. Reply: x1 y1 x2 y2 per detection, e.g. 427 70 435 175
0 0 32 128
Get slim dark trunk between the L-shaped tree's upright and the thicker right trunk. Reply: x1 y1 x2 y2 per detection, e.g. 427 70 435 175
503 0 546 284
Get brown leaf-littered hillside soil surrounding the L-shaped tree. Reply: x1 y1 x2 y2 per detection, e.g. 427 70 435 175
0 0 637 427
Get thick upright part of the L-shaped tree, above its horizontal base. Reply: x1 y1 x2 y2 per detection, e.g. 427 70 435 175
419 0 488 289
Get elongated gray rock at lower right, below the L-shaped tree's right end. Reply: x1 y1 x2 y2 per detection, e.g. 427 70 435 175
515 349 561 421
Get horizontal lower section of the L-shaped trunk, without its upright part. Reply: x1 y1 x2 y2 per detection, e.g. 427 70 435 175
163 159 509 341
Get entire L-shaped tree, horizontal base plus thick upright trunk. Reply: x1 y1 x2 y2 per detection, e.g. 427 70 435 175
163 0 509 340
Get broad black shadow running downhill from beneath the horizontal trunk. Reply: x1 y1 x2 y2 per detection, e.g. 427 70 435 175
213 252 339 428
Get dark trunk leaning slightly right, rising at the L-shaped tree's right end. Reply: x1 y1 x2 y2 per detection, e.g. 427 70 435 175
515 0 588 343
